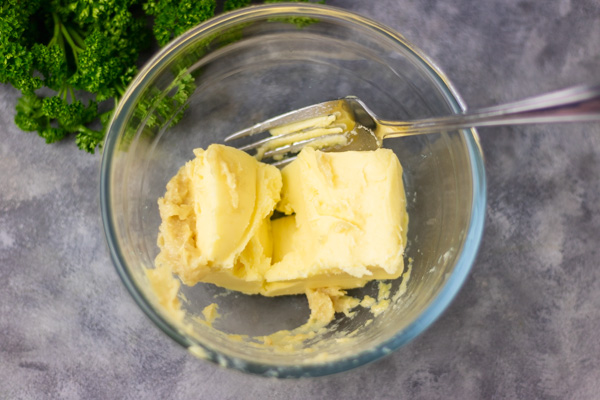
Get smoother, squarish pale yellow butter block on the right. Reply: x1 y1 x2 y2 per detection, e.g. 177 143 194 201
265 148 408 295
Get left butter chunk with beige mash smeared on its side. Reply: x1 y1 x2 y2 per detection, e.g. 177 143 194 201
156 144 282 293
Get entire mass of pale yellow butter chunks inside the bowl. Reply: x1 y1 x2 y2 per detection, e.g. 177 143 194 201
156 144 408 323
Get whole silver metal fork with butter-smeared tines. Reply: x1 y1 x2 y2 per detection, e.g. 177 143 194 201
225 84 600 166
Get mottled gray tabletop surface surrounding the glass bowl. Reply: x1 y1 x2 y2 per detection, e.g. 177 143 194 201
0 0 600 399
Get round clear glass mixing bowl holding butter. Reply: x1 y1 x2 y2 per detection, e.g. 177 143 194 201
100 3 486 377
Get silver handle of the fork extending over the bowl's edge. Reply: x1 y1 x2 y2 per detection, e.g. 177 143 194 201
378 84 600 139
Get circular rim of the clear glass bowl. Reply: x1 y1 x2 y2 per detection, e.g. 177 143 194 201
100 3 487 378
